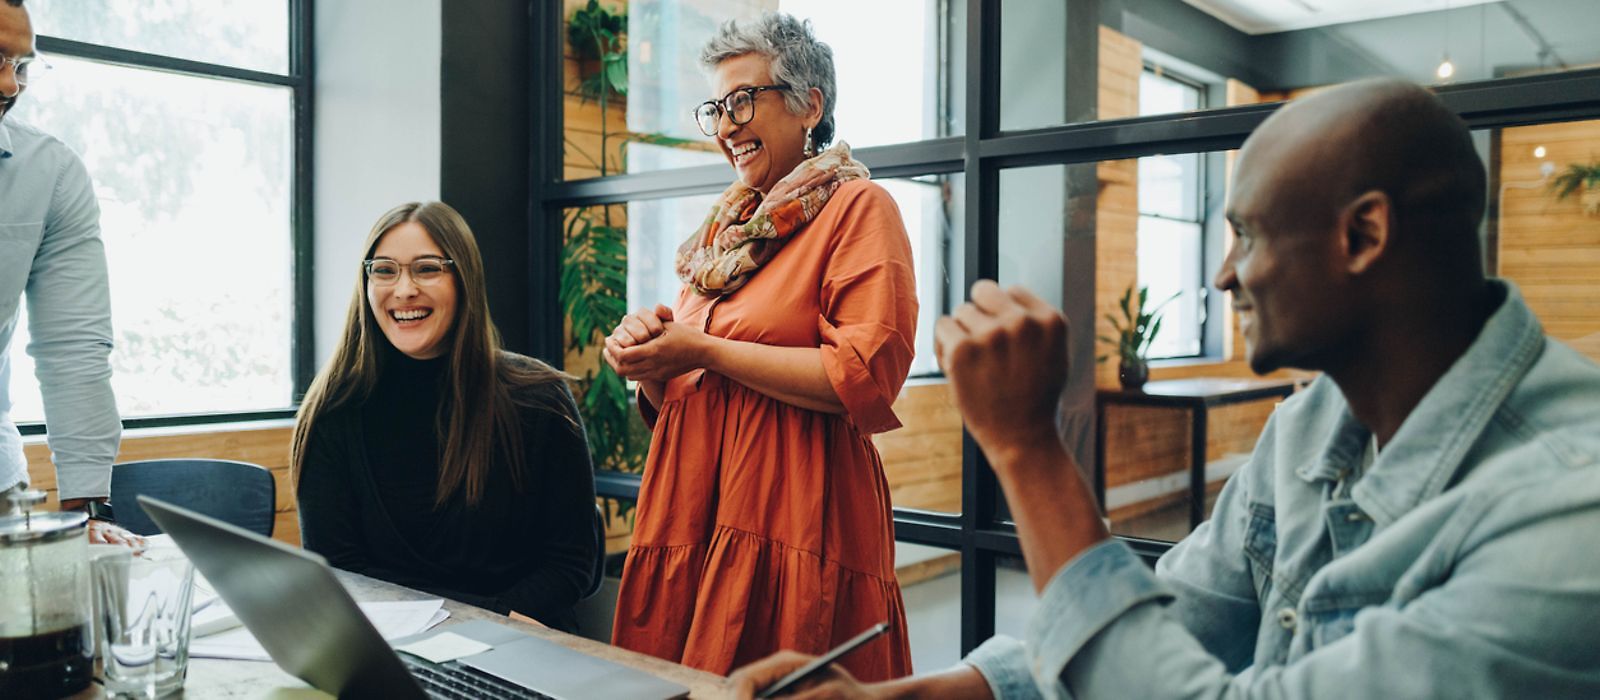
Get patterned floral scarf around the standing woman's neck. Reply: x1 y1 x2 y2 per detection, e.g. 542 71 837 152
677 141 872 297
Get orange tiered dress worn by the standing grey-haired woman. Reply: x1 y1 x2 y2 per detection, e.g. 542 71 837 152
611 181 917 681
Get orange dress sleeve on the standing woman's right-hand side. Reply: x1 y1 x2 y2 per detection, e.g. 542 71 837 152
818 181 917 435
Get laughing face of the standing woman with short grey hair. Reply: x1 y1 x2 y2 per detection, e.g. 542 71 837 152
712 53 821 195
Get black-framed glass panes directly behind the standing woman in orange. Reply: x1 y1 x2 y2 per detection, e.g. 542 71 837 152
552 0 965 511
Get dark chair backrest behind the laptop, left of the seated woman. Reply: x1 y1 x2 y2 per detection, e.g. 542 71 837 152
110 459 277 537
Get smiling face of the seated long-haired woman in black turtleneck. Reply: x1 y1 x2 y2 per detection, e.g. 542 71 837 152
366 221 456 360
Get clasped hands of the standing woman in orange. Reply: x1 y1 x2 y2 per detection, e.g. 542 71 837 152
602 304 710 382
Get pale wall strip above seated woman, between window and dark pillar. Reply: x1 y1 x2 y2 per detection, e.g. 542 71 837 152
314 0 443 366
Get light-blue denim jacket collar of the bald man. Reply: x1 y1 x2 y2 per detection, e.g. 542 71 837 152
1296 280 1544 526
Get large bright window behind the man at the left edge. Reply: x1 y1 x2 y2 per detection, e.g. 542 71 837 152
6 0 310 422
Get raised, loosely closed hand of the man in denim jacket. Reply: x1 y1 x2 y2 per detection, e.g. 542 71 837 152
934 280 1067 468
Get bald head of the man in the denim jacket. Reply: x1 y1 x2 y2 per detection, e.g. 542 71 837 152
1216 80 1485 372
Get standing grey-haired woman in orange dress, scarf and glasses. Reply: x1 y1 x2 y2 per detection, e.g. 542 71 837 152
605 14 917 681
